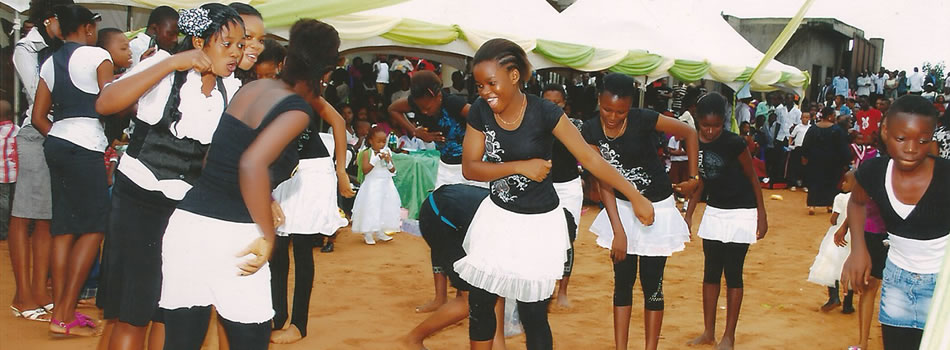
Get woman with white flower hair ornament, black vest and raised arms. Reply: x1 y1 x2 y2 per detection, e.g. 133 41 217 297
96 4 245 349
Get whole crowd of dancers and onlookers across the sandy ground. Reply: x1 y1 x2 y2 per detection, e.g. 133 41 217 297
0 0 950 350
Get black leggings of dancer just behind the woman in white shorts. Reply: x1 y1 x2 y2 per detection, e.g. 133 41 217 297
270 234 314 337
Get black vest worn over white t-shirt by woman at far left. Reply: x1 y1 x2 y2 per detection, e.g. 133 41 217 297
50 42 99 122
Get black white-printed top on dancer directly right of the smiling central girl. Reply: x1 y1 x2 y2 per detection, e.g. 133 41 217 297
581 108 673 202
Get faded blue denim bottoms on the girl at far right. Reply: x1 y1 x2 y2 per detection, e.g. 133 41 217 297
879 259 937 329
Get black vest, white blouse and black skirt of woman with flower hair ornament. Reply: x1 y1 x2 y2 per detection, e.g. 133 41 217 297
97 51 241 327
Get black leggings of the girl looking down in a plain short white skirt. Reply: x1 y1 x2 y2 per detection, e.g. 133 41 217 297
703 239 749 288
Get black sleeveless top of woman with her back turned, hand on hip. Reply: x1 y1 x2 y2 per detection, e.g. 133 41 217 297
178 94 314 223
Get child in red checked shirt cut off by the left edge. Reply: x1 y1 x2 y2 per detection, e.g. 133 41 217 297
0 100 20 240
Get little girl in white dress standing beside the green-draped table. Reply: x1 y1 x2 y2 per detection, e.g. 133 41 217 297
352 128 401 244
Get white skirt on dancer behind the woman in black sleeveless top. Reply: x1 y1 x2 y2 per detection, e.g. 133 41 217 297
274 157 347 236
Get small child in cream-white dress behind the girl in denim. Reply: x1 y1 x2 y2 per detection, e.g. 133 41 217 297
808 172 854 314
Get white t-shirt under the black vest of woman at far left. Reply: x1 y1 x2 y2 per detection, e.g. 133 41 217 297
40 46 112 152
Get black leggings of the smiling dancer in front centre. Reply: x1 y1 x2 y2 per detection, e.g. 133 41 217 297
468 288 554 350
